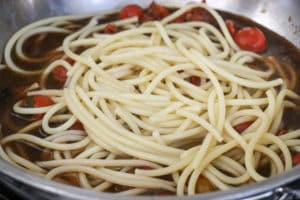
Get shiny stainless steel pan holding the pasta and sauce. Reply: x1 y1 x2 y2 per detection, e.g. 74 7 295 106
0 0 300 200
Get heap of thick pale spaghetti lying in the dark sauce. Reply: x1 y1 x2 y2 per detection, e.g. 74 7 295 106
0 1 300 195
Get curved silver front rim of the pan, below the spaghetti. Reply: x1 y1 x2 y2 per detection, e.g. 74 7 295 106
0 159 300 200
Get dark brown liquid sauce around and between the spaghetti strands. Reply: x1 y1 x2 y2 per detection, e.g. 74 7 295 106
0 8 300 194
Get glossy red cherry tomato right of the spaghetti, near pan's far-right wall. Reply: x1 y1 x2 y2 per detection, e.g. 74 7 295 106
233 27 267 52
